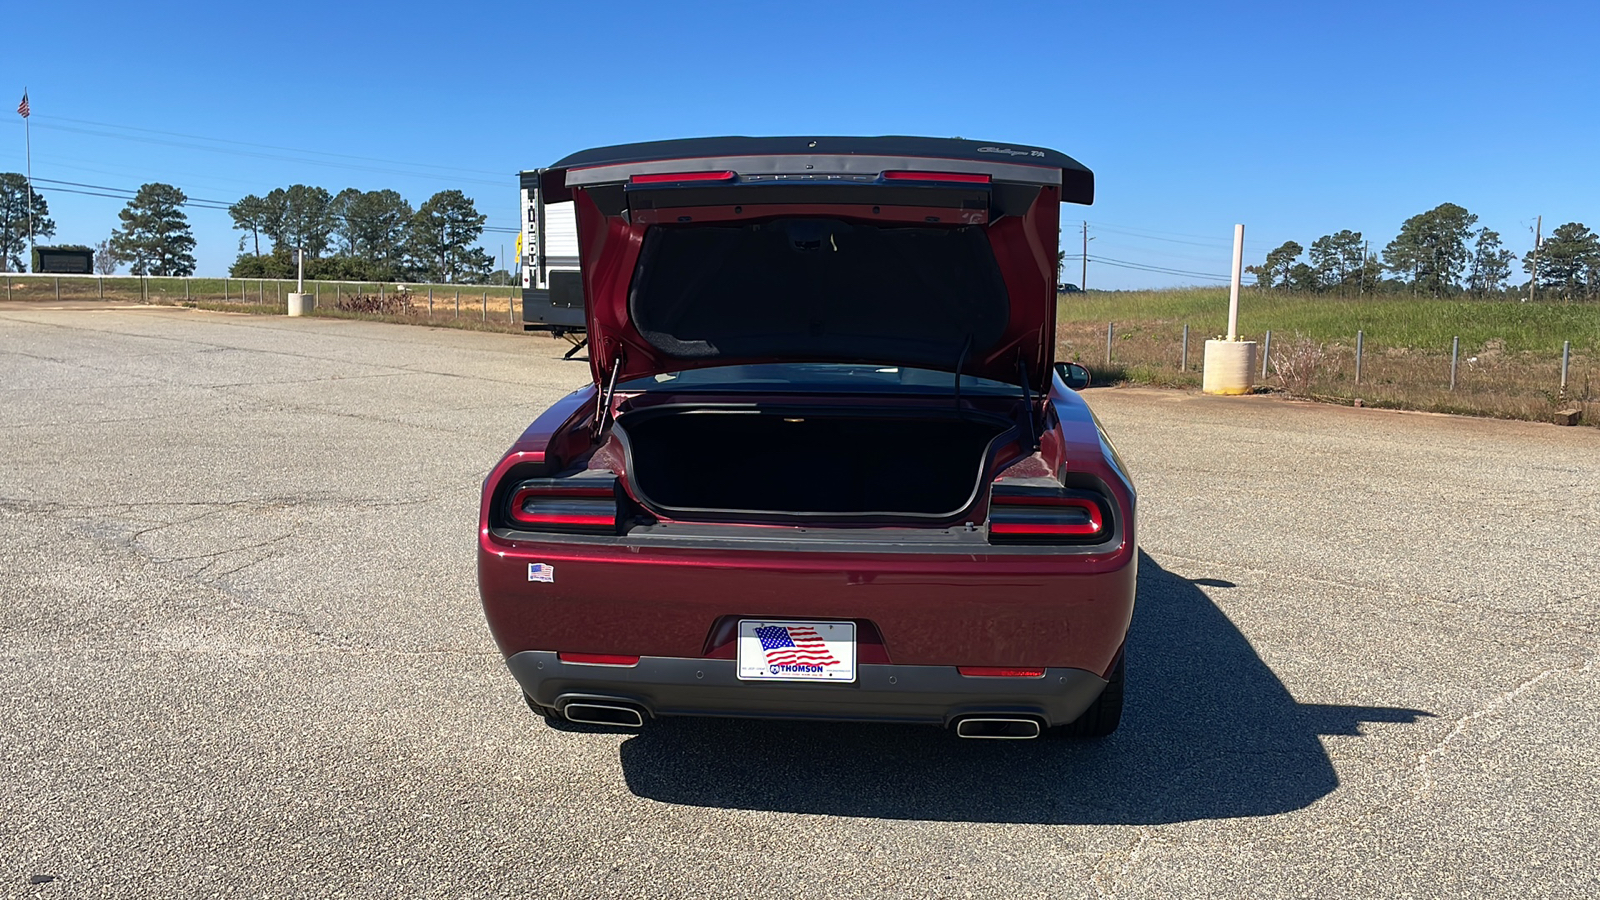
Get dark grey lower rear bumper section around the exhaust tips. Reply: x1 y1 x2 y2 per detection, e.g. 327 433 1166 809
507 650 1106 727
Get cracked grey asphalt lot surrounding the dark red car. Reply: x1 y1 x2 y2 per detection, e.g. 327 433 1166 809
0 306 1600 898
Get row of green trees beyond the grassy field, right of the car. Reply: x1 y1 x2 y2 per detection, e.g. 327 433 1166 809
1246 203 1600 299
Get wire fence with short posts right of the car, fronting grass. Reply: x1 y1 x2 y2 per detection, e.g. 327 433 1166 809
1056 322 1600 424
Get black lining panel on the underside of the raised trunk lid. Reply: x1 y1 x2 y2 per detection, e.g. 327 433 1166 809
629 218 1010 368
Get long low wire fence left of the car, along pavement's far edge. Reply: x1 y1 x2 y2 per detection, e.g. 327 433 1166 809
0 274 522 325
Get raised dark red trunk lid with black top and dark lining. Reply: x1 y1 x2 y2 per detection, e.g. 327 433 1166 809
539 138 1094 394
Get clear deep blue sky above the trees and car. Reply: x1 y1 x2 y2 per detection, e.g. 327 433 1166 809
0 0 1600 288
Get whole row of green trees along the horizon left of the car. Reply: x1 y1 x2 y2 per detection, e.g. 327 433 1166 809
0 171 510 283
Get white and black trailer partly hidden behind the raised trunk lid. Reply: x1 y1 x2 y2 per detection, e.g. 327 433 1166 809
517 170 584 336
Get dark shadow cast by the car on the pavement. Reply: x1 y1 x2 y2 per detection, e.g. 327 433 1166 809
621 552 1430 825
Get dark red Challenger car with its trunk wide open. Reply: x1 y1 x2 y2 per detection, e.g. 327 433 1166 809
478 138 1136 738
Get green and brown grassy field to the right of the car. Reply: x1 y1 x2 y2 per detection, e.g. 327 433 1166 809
1058 288 1600 424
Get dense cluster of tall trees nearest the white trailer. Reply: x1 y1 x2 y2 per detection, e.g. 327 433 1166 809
227 184 509 283
